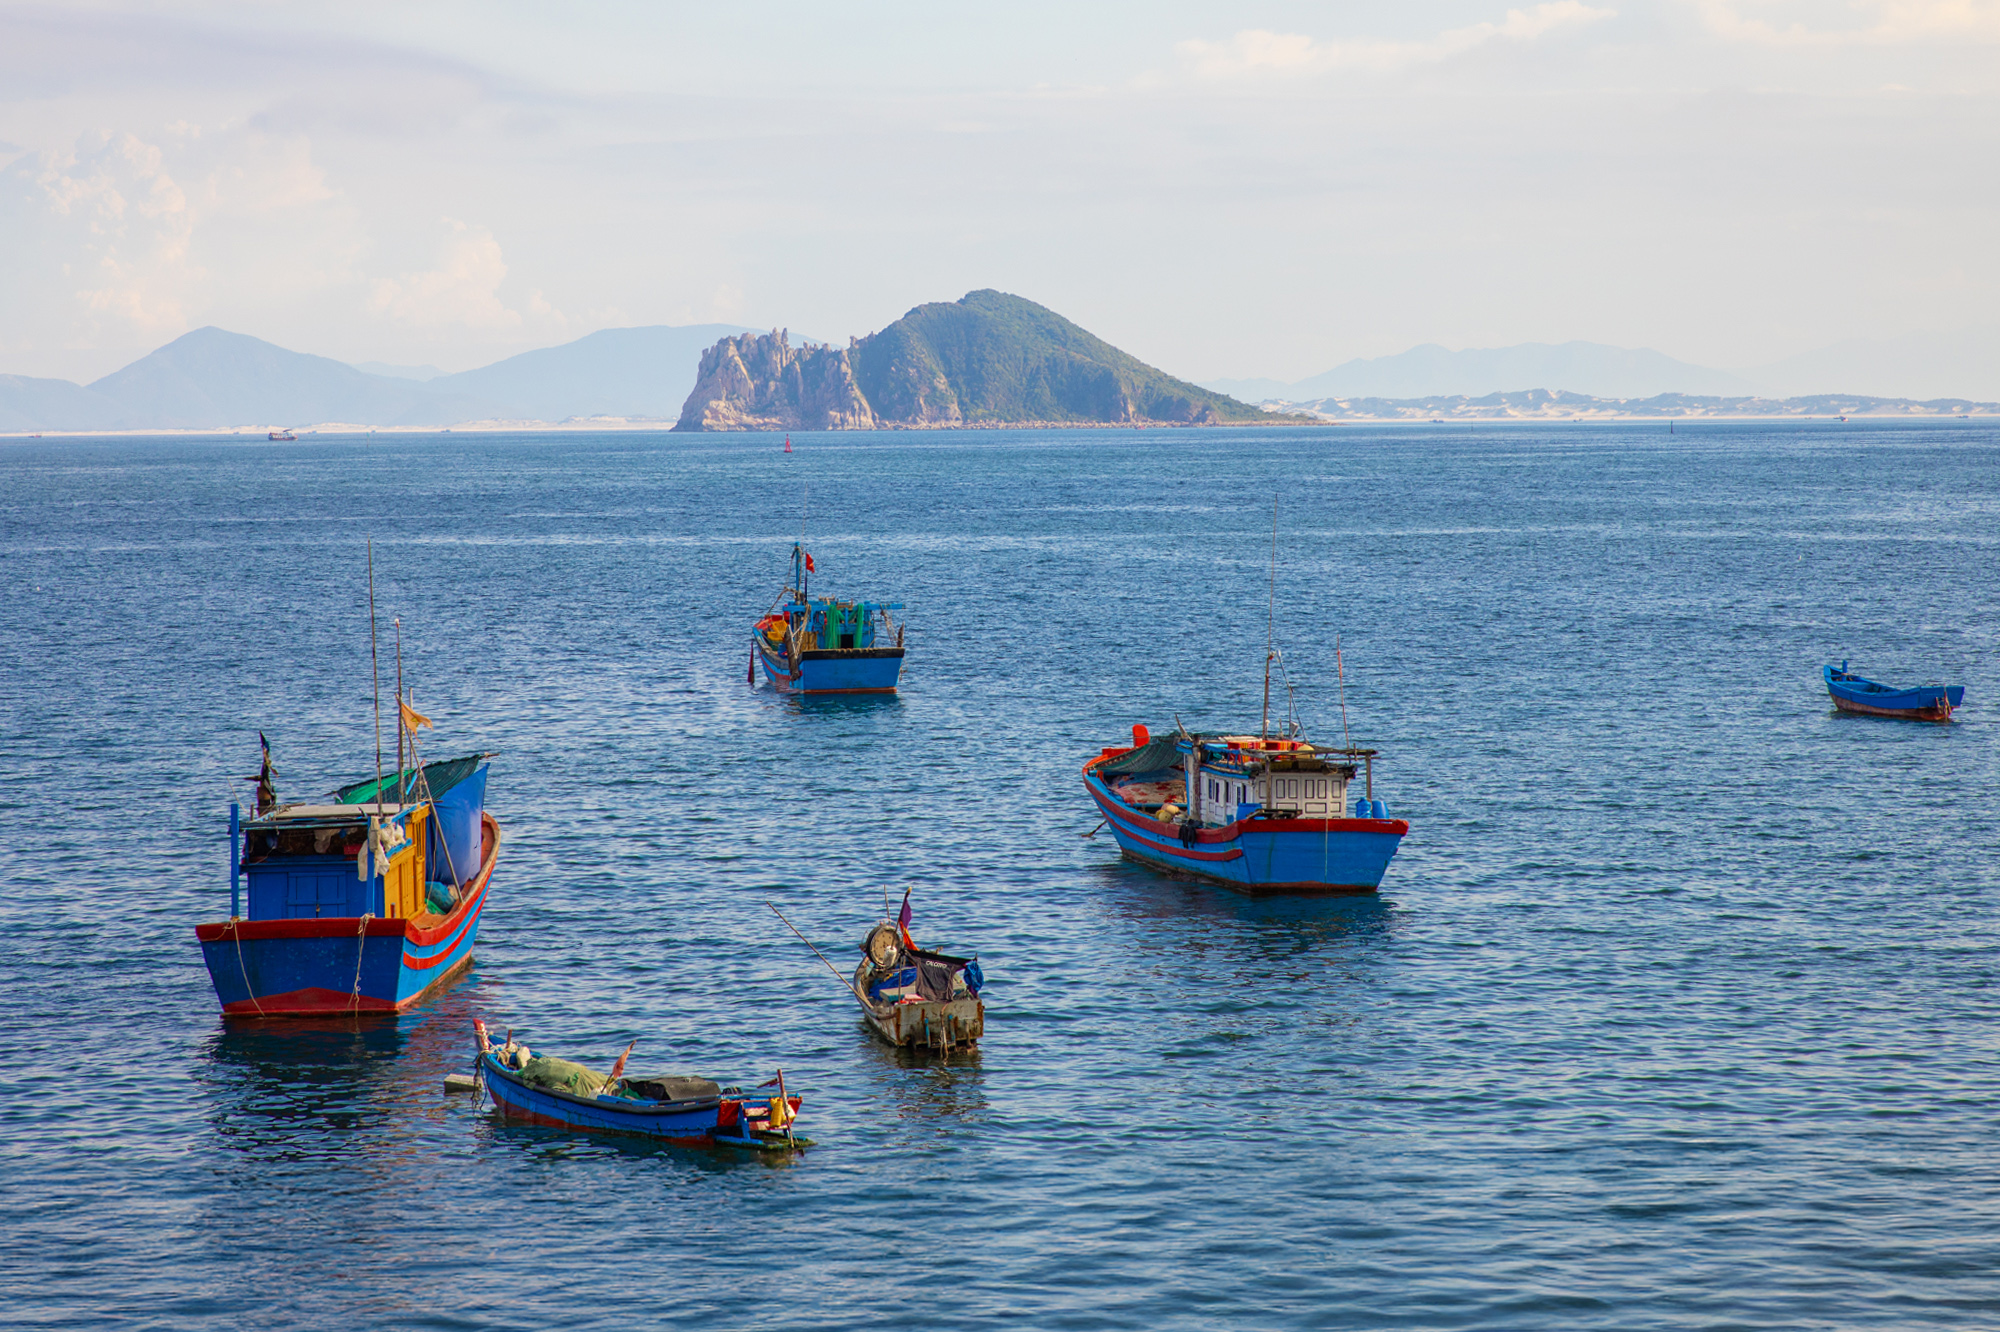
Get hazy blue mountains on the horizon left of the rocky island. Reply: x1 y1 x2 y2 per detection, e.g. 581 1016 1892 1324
0 324 746 432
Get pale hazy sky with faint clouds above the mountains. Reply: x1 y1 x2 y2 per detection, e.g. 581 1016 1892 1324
0 0 2000 382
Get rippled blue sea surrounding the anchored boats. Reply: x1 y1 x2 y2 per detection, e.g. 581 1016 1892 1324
0 422 2000 1330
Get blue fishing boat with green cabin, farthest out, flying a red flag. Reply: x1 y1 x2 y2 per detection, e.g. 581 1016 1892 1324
748 546 904 694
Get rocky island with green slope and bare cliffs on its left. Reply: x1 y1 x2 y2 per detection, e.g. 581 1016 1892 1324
674 290 1280 430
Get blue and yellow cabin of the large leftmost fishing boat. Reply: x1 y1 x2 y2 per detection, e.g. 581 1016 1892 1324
230 754 488 920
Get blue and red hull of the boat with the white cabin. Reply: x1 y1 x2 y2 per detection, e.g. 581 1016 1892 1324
1084 770 1410 896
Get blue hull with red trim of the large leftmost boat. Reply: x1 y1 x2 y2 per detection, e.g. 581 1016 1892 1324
194 808 498 1018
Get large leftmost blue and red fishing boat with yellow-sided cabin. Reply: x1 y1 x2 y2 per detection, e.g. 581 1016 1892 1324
194 740 500 1018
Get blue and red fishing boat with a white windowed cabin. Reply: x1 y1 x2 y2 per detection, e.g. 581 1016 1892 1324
1084 726 1410 896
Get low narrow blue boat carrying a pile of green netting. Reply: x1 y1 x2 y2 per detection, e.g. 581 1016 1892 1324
472 1022 812 1152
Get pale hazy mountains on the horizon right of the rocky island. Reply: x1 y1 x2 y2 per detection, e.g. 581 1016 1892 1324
1202 324 2000 402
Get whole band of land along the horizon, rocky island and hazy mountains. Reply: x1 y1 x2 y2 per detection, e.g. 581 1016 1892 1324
0 314 2000 432
